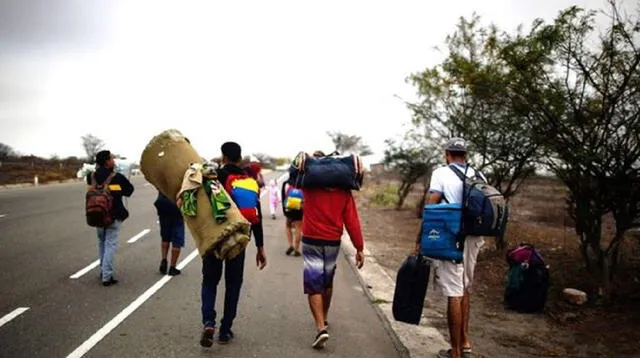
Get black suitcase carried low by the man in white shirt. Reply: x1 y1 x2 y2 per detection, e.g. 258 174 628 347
392 255 431 324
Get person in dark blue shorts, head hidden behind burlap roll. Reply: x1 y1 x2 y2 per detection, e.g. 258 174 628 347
154 192 184 276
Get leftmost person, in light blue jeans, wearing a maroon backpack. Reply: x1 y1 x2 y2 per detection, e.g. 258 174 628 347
86 150 134 287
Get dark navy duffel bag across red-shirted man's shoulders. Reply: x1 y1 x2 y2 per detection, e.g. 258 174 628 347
289 152 364 190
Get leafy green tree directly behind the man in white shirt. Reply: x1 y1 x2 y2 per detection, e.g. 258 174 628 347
409 14 541 200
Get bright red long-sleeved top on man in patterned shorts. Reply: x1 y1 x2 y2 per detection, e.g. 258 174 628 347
302 189 364 251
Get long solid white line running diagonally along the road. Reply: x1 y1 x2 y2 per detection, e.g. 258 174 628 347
67 250 198 358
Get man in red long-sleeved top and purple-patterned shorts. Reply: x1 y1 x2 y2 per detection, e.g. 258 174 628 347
302 151 364 349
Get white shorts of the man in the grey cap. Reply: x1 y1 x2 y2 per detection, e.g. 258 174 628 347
431 236 484 297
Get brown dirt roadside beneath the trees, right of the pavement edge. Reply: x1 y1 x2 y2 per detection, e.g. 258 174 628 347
357 176 640 358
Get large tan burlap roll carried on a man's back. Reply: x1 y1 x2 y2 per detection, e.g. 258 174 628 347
140 129 251 259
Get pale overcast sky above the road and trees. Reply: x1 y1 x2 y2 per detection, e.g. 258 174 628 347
0 0 620 160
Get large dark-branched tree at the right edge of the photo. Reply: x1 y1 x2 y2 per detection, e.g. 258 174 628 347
501 1 640 294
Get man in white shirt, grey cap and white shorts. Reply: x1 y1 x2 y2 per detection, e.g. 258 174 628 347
414 138 486 358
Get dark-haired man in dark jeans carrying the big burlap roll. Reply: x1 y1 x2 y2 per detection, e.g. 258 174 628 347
200 142 267 347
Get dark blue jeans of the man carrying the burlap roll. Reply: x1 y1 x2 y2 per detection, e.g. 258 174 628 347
201 251 245 333
